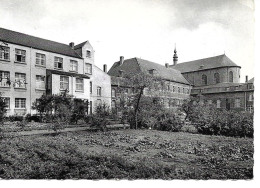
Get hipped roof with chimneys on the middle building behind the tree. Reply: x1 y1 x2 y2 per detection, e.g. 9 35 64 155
108 57 190 85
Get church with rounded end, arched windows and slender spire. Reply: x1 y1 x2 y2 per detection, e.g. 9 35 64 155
170 52 254 112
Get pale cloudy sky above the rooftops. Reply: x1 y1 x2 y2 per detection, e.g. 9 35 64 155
0 0 254 82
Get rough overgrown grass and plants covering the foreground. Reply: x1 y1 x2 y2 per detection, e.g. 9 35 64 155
0 129 254 179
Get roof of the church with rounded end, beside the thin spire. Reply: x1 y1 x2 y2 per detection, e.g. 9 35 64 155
170 54 241 73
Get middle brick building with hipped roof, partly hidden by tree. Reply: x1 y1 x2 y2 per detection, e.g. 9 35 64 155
108 56 192 108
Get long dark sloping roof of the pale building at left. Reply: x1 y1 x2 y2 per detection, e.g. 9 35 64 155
0 28 81 58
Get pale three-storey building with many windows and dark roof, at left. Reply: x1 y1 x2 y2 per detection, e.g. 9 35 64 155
0 28 111 115
